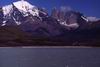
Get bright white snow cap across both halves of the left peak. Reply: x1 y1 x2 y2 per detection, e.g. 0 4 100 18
3 1 39 16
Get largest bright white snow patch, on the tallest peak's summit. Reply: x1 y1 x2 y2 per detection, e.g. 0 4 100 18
13 1 39 16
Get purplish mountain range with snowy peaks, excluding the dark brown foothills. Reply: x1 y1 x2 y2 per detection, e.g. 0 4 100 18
0 1 99 36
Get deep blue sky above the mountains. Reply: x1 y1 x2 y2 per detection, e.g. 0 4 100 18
0 0 100 18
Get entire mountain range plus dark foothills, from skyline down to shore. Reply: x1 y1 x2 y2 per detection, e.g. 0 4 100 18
0 1 100 45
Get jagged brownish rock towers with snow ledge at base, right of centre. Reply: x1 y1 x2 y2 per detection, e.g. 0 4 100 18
52 7 86 30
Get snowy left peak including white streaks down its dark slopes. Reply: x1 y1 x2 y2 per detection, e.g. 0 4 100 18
1 1 39 26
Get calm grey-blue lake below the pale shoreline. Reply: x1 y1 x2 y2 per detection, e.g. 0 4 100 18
0 47 100 67
